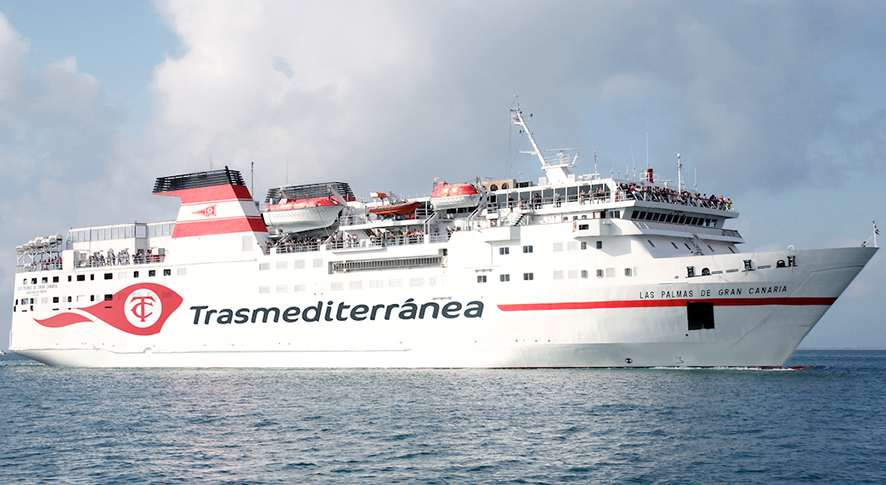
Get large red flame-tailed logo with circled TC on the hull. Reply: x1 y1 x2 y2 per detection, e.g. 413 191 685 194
34 283 183 335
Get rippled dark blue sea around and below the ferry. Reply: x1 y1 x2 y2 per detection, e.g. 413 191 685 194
0 350 886 484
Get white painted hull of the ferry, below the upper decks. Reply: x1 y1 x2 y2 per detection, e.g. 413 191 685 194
11 231 875 368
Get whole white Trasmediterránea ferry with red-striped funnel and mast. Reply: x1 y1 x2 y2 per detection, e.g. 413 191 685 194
9 103 877 368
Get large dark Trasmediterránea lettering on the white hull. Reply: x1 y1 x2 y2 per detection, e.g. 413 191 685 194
190 295 486 325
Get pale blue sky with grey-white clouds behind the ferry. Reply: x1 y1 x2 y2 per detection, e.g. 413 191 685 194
0 0 886 349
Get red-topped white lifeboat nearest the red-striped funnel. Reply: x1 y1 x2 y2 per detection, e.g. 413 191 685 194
262 197 342 232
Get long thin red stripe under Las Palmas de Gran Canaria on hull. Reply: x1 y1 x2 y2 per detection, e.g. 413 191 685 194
498 297 837 312
